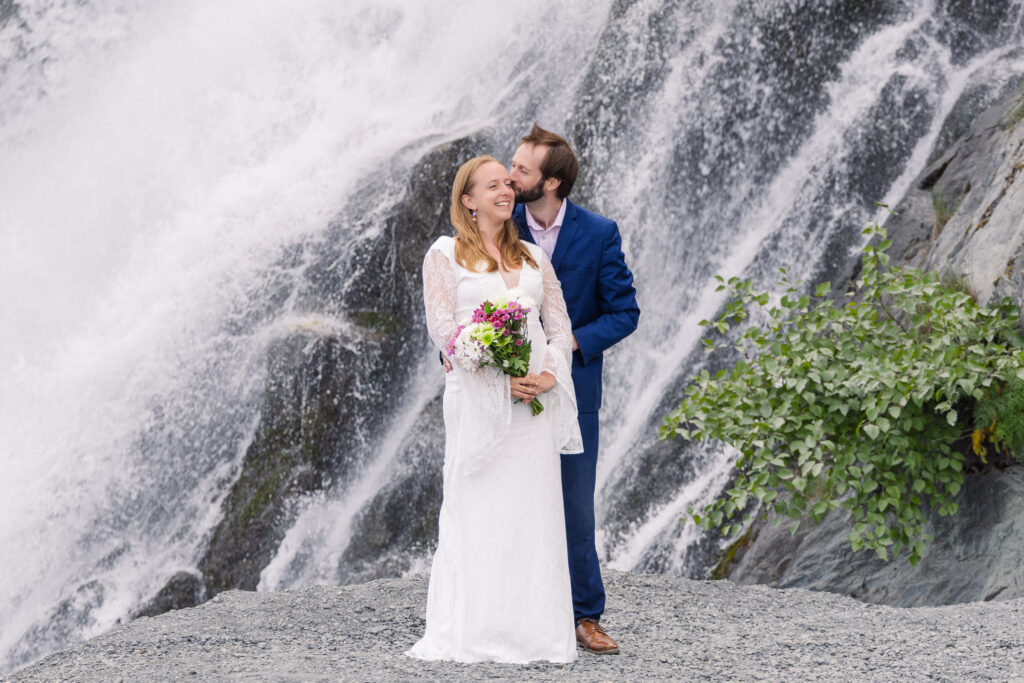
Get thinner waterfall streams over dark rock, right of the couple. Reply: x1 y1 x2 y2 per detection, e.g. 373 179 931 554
589 1 1024 575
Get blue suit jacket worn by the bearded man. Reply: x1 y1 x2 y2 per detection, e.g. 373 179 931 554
512 201 640 413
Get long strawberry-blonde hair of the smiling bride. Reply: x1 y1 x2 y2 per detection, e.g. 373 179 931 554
451 155 539 271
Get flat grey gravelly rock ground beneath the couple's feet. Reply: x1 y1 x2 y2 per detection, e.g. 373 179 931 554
4 572 1024 681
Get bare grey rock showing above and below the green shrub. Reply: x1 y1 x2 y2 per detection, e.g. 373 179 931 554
724 90 1024 606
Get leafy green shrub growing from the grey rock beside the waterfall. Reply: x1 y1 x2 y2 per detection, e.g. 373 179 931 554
660 220 1024 564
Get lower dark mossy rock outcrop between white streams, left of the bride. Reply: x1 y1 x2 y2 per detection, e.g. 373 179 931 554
200 331 376 597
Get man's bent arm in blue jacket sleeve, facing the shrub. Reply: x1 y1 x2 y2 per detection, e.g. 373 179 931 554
572 222 640 365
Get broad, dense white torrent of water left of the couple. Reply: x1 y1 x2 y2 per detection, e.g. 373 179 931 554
0 0 605 671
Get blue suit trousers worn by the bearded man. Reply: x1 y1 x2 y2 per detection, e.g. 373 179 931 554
562 413 604 623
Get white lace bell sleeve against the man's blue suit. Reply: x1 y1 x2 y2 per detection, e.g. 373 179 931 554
538 250 583 454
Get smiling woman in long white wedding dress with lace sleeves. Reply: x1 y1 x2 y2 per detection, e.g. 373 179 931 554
407 157 583 663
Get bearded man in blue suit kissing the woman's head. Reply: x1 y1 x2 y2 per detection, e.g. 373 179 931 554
509 124 640 654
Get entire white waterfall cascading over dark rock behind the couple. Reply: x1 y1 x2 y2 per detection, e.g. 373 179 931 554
0 0 1024 673
